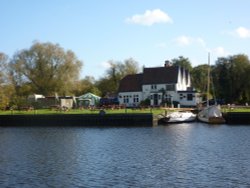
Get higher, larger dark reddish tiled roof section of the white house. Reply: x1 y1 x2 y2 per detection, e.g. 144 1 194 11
143 66 179 84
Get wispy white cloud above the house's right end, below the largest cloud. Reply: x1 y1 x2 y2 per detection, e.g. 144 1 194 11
175 35 206 48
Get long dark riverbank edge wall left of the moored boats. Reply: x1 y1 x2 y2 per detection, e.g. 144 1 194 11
0 113 153 127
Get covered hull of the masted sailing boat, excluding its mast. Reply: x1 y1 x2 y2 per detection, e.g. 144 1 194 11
198 105 225 124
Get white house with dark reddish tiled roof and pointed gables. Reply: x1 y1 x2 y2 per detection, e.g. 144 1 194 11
118 63 200 107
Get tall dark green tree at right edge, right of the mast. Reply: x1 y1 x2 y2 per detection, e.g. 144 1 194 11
213 54 250 103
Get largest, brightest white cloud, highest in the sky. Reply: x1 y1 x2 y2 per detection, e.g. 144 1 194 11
126 9 173 26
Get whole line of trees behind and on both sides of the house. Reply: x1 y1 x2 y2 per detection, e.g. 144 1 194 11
0 42 250 108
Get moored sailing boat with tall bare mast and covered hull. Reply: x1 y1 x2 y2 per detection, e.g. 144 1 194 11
197 54 225 124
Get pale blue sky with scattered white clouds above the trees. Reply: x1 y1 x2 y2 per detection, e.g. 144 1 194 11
0 0 250 79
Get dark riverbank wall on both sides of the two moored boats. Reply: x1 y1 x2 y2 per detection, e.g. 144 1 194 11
0 112 250 127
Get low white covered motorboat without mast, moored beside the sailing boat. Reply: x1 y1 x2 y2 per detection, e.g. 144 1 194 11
159 111 196 123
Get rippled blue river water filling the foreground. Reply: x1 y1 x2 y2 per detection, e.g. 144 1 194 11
0 123 250 187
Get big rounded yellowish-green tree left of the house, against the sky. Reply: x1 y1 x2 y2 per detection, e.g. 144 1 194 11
11 42 82 95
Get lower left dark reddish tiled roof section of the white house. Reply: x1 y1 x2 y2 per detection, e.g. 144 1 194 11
119 74 142 92
